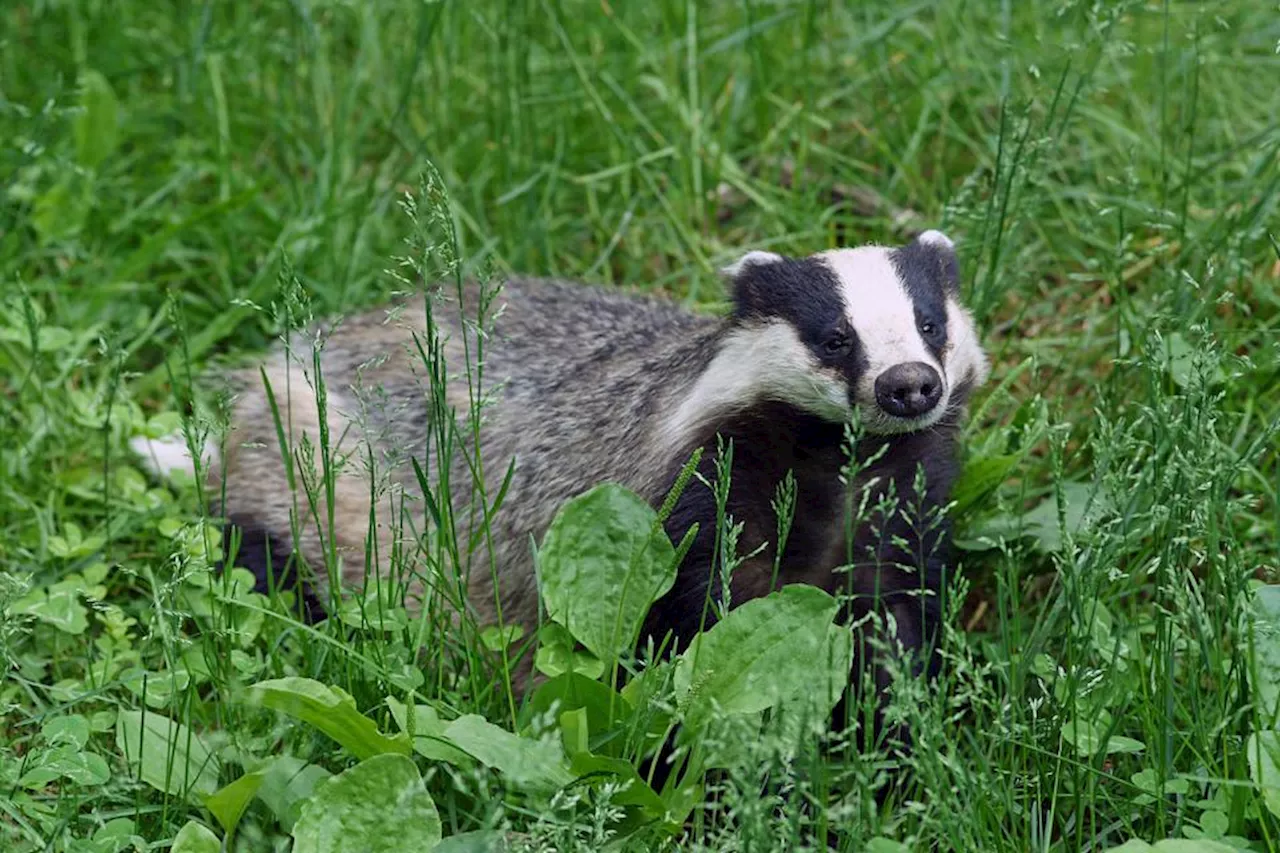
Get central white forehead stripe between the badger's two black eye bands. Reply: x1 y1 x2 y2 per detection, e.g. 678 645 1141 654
819 246 942 383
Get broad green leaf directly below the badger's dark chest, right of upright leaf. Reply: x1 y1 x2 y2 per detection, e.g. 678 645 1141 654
676 584 847 733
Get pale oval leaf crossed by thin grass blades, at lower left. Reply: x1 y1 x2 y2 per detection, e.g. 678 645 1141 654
115 711 218 804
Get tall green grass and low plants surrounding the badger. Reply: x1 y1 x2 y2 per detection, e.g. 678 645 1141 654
0 0 1280 852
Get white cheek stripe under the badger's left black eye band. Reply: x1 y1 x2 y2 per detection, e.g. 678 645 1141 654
663 320 850 443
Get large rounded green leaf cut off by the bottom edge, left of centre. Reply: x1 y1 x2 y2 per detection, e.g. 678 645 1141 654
293 754 440 853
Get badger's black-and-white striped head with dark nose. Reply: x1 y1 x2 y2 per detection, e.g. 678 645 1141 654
684 231 987 434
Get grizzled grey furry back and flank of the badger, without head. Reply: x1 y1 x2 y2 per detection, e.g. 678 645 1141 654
209 279 719 624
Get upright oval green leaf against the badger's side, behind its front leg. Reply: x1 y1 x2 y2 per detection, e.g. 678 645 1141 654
538 483 676 665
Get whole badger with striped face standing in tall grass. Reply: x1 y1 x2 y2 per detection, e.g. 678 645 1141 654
136 231 988 732
